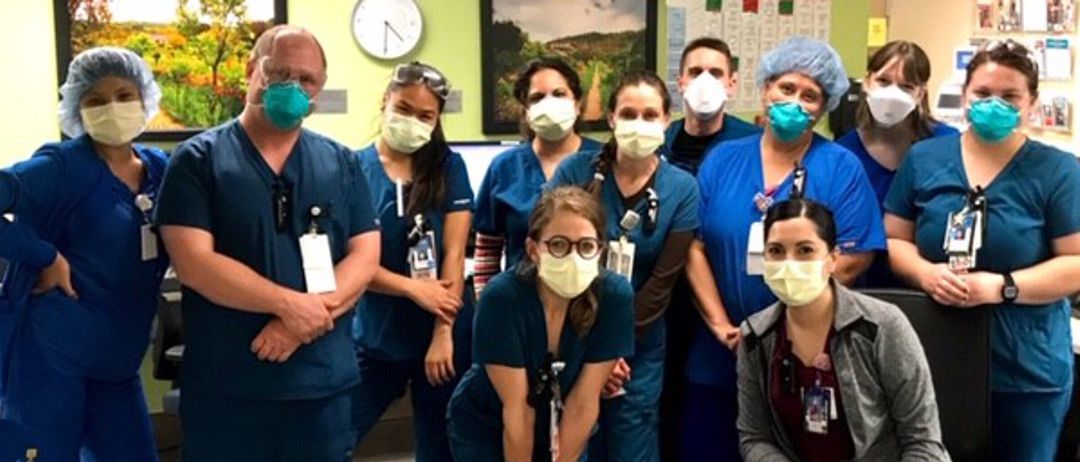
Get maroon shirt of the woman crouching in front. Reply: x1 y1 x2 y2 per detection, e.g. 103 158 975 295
769 316 855 462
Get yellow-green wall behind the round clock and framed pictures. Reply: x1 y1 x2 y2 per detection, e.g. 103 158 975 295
0 0 869 409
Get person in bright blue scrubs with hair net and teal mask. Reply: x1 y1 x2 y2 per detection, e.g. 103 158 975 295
681 38 885 460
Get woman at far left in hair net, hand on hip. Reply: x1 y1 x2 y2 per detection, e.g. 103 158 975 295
0 47 168 461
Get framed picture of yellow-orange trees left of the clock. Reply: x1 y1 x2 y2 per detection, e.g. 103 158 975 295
53 0 286 141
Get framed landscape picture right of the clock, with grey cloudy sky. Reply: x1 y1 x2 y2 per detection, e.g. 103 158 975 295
481 0 657 134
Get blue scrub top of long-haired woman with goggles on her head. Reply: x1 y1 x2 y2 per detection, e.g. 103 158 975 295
352 145 473 361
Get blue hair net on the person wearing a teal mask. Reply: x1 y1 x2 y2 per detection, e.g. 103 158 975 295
757 37 851 112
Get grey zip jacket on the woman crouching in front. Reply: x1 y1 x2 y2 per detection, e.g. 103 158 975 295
738 283 949 462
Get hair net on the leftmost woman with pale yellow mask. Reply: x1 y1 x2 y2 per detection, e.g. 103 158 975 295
59 46 161 138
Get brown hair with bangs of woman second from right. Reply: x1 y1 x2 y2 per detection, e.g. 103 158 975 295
855 40 937 139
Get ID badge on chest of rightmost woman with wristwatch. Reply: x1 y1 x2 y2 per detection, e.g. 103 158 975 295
943 187 986 273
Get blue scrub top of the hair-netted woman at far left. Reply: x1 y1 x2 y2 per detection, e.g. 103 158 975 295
0 135 168 380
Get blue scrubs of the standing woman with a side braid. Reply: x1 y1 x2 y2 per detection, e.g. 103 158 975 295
551 151 699 461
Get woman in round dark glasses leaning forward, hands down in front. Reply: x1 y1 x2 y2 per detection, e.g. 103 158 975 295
449 187 634 462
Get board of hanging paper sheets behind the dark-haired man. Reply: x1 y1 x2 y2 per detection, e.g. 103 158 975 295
665 0 832 112
